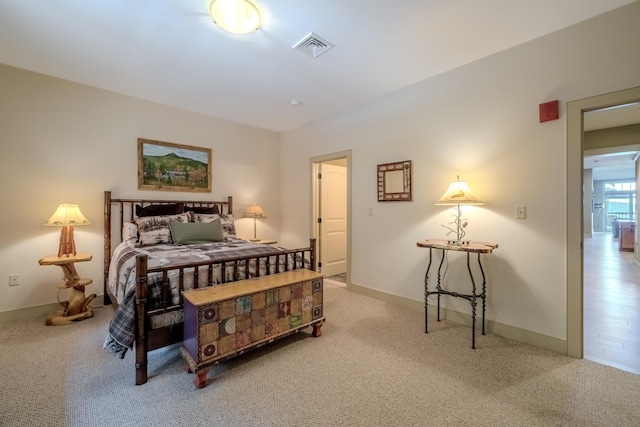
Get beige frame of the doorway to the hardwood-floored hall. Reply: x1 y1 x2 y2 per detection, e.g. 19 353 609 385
566 87 640 359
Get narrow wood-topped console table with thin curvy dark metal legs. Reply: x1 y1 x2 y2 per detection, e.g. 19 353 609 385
416 239 498 349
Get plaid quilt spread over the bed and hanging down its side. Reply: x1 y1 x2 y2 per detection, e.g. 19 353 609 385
104 239 293 358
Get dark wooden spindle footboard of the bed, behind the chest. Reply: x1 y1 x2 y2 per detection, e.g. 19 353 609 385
135 239 316 385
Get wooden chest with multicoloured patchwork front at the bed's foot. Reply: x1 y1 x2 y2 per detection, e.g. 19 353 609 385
181 269 324 388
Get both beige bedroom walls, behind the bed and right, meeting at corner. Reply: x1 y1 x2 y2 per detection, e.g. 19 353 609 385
0 2 640 352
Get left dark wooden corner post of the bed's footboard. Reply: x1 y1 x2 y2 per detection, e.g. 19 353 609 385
135 255 148 385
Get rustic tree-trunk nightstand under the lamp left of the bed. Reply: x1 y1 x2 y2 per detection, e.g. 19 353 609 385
39 254 96 326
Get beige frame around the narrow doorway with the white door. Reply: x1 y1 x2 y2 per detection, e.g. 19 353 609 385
309 150 351 287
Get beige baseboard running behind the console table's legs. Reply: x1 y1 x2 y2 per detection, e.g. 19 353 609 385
347 283 567 354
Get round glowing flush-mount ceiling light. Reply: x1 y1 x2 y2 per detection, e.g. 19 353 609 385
209 0 262 34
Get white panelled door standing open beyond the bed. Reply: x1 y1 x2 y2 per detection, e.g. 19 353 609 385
318 163 347 276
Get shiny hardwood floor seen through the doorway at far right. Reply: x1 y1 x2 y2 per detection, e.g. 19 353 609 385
584 232 640 374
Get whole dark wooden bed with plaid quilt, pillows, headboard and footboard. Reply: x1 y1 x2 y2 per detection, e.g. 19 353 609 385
104 191 316 385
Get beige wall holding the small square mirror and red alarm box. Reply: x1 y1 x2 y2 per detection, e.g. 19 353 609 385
281 2 640 348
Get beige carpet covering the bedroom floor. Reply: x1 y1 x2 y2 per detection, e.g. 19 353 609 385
0 280 640 427
